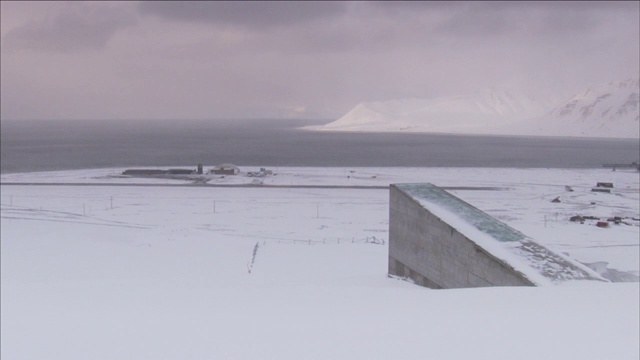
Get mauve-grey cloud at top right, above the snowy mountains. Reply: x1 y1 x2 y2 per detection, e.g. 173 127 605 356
368 1 638 38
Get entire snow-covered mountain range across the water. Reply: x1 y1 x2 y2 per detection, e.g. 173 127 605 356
309 79 640 138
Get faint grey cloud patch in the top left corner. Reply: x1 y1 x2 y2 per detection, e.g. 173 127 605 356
3 3 136 52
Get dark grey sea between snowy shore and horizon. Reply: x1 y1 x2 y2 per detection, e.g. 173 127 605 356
0 120 640 174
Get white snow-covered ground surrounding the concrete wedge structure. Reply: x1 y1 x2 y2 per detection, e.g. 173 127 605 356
0 167 640 359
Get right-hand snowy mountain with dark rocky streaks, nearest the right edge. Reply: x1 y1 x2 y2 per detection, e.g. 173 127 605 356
513 79 640 138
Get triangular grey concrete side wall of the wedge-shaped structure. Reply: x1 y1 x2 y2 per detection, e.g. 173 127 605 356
389 185 534 289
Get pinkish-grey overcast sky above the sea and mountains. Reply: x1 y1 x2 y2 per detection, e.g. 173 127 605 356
0 1 640 119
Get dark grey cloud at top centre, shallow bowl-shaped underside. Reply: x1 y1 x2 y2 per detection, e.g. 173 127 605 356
139 1 346 29
